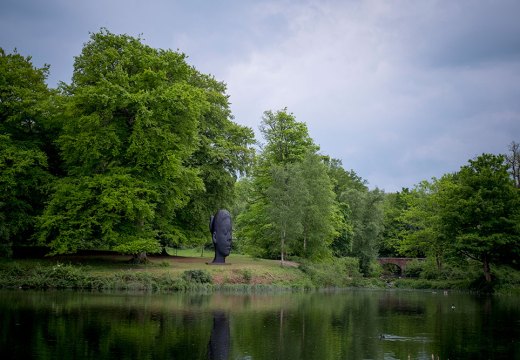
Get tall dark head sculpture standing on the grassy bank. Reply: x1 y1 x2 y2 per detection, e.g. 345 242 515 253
209 210 232 264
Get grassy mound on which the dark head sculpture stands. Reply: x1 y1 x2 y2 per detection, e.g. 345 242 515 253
0 249 313 291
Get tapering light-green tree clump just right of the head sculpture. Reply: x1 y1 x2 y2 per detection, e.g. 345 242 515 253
236 109 340 261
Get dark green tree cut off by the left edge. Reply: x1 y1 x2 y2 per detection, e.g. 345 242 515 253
0 48 55 253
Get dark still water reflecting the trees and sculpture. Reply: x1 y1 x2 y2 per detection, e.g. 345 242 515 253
0 290 520 360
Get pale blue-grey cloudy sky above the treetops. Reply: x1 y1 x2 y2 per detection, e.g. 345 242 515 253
0 0 520 192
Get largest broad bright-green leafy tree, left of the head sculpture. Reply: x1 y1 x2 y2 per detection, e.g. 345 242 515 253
36 29 251 255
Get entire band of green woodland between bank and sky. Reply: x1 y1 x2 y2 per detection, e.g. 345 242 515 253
0 29 520 290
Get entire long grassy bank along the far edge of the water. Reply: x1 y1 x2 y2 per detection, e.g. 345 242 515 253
0 251 520 292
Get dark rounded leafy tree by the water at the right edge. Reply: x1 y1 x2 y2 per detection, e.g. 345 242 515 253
441 154 520 283
